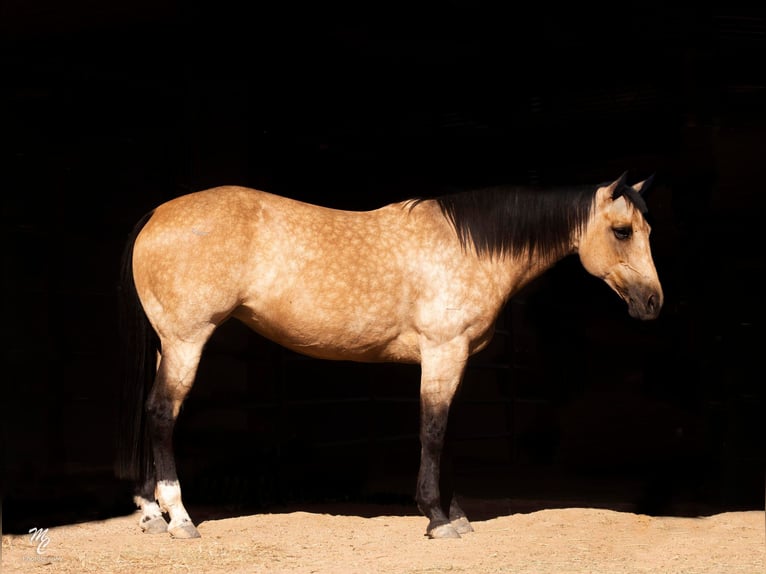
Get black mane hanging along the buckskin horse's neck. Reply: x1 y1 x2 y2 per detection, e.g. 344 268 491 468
424 186 597 259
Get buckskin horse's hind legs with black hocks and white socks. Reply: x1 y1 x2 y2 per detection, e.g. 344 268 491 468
144 337 207 538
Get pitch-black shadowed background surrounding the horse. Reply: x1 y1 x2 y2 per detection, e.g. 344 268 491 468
0 0 766 532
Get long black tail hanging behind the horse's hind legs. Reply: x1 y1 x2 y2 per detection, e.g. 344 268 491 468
115 212 159 485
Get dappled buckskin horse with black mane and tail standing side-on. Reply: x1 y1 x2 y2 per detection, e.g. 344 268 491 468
118 172 663 538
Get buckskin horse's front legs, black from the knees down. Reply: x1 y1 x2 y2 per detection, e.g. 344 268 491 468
415 345 473 538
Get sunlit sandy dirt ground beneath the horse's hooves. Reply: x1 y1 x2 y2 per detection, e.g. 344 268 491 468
2 500 766 574
